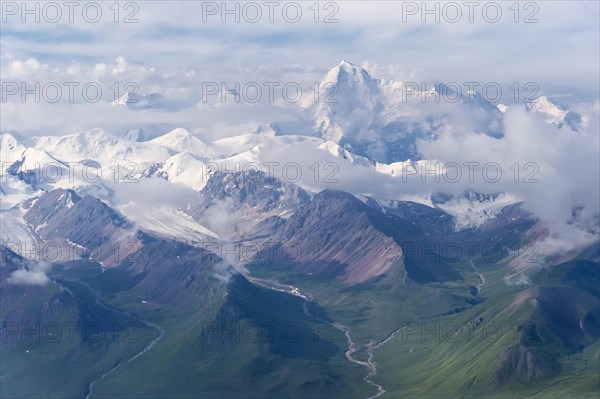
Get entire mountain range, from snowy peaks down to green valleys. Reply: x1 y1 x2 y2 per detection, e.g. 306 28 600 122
0 61 600 398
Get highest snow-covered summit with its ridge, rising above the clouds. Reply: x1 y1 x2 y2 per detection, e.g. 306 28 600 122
300 61 502 163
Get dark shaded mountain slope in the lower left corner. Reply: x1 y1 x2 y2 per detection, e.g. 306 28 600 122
0 247 156 398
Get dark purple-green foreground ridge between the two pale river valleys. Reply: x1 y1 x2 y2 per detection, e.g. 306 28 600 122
85 237 371 398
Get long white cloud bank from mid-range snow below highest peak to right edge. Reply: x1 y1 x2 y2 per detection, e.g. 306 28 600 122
200 102 600 255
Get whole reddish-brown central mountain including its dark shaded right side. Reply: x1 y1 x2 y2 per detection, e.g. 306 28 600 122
257 190 459 285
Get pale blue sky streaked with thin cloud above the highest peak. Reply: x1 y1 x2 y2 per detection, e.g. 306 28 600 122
1 1 600 83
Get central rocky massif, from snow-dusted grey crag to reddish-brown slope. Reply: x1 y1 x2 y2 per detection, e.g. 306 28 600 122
193 171 468 286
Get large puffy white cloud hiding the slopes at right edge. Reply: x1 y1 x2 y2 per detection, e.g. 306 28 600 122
418 102 600 245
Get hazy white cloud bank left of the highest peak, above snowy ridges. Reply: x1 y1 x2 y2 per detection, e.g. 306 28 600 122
0 56 323 137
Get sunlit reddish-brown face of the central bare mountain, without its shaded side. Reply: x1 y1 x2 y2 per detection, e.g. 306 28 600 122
259 190 406 284
